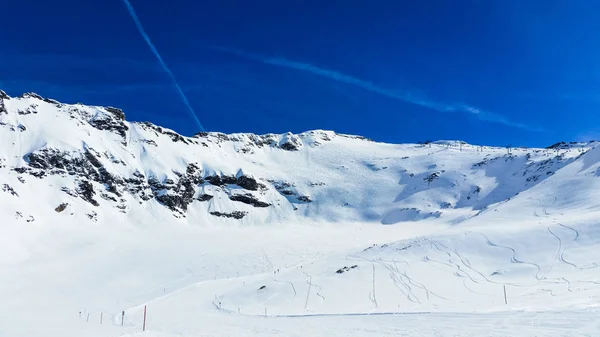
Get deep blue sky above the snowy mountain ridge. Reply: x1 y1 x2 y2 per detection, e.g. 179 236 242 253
0 0 600 146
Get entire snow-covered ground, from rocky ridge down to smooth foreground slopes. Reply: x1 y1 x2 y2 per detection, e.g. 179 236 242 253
0 91 600 337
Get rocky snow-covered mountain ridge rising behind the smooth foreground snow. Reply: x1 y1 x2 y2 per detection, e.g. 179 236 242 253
0 92 590 226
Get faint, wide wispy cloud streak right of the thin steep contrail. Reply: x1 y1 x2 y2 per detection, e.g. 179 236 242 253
205 46 542 131
